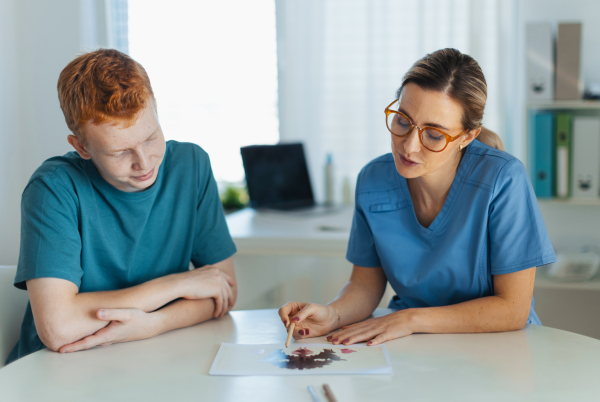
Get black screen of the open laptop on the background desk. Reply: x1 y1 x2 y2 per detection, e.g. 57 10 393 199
241 143 315 209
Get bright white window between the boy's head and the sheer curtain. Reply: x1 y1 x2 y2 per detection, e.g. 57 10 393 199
128 0 279 182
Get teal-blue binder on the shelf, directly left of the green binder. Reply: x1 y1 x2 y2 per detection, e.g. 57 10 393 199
529 111 555 198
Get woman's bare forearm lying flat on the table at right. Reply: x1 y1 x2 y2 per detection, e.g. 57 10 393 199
412 296 529 333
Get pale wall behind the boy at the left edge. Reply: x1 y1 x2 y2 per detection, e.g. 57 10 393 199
0 0 106 265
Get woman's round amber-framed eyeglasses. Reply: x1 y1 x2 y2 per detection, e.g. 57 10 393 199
385 99 469 152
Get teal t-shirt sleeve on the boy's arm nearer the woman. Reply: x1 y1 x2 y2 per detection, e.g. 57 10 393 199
192 148 236 267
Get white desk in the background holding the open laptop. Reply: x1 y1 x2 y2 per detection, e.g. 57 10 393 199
227 207 394 310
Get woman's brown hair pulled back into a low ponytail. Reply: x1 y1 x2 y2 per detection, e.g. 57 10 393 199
396 48 504 151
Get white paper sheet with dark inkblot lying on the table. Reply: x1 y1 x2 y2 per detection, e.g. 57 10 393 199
209 343 393 375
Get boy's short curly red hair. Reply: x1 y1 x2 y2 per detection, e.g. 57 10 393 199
57 49 154 139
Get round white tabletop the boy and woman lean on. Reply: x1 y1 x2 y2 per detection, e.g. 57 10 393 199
0 310 600 402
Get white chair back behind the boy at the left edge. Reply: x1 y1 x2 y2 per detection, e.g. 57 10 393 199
0 265 29 367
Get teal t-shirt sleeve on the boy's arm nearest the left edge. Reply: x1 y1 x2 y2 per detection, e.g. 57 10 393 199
15 177 83 289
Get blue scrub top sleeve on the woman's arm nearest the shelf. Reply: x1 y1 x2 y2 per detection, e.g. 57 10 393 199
489 159 556 275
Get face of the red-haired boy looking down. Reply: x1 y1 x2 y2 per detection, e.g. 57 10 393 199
69 100 165 192
